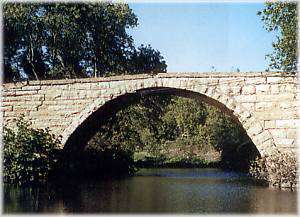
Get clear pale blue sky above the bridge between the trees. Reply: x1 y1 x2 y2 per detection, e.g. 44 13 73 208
128 3 275 72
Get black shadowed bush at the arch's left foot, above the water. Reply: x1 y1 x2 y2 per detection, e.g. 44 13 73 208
57 147 136 180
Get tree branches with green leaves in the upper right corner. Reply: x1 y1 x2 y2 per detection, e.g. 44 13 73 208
258 1 298 74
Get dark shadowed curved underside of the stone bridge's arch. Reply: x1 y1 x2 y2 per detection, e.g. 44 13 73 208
64 87 260 164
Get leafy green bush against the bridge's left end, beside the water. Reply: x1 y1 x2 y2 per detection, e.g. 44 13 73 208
3 118 59 184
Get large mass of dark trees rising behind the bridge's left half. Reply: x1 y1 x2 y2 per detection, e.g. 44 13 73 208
3 2 166 81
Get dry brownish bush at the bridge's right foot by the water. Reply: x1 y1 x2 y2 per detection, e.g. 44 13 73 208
249 153 297 188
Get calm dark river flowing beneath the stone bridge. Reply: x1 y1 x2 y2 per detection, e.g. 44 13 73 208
3 168 297 214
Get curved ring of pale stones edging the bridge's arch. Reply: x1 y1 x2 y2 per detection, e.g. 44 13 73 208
62 83 276 156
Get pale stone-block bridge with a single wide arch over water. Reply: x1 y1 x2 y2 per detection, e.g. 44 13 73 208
1 72 300 155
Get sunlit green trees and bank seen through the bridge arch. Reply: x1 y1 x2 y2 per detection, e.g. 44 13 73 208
86 94 258 169
